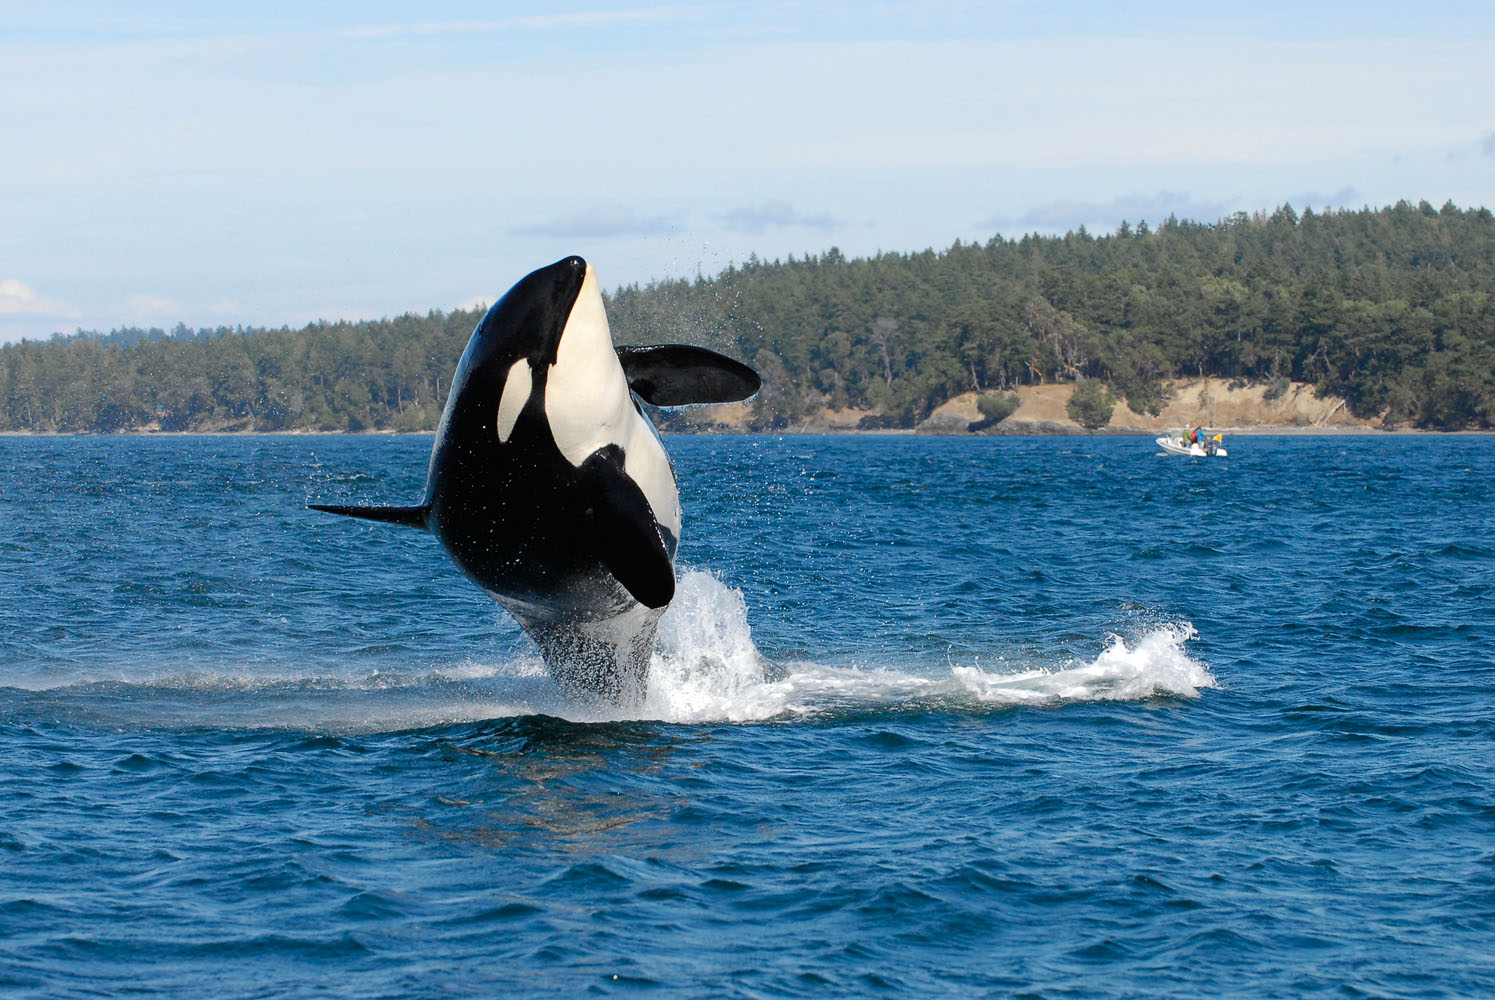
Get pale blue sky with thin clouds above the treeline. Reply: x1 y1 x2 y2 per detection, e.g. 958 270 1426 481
0 0 1495 341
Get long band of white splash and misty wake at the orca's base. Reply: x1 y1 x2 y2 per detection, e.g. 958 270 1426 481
11 571 1217 731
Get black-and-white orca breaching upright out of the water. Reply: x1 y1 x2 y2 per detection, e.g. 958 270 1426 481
309 257 759 703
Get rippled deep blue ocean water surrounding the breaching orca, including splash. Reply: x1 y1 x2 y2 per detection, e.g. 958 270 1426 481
0 436 1495 1000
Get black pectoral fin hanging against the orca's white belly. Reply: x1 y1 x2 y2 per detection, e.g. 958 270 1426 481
582 445 674 608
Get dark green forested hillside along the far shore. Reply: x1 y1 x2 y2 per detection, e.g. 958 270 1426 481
0 202 1495 432
